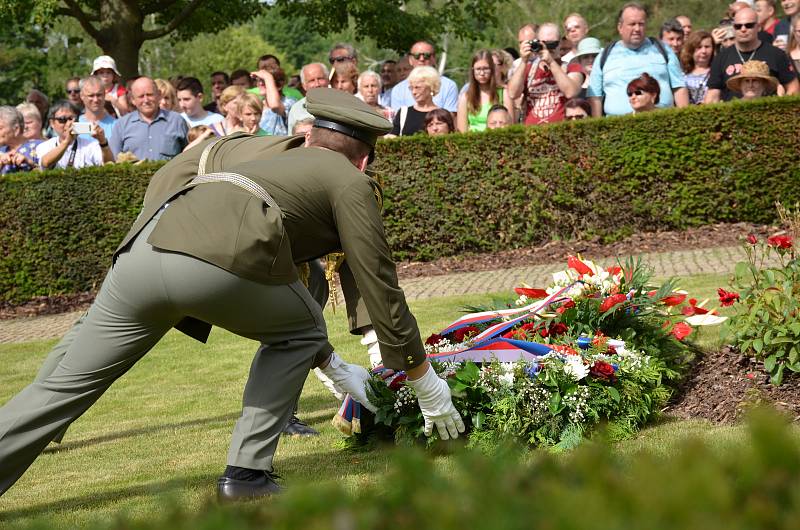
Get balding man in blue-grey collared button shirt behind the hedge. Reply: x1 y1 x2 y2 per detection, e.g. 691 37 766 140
109 77 189 160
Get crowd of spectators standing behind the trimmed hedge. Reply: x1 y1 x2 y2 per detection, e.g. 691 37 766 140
0 0 800 174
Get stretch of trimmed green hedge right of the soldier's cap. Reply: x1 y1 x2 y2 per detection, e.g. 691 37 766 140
377 97 800 260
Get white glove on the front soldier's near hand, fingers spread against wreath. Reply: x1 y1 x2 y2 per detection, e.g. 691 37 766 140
406 365 464 440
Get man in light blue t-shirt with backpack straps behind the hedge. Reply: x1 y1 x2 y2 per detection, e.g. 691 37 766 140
587 2 689 116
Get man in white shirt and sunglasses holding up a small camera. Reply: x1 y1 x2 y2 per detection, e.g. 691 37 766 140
36 100 114 169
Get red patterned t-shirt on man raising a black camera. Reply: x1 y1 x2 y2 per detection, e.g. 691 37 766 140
523 61 584 125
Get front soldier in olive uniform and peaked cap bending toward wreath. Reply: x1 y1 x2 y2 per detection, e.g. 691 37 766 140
0 89 464 499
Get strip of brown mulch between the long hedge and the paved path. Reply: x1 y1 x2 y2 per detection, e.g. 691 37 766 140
0 219 777 320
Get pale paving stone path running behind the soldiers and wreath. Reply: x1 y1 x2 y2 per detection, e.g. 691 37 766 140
0 246 764 344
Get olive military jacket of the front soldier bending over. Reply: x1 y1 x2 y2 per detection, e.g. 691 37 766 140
115 142 425 369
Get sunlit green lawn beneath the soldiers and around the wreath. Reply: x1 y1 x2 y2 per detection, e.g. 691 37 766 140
0 276 744 528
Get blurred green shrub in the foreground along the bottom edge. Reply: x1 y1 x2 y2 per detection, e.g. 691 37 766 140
43 410 800 530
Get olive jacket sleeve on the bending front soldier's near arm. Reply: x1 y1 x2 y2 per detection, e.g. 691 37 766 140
333 177 425 370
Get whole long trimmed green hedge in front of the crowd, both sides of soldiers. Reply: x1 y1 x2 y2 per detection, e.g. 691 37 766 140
0 97 800 303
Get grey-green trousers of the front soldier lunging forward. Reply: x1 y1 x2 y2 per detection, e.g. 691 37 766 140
0 212 327 495
